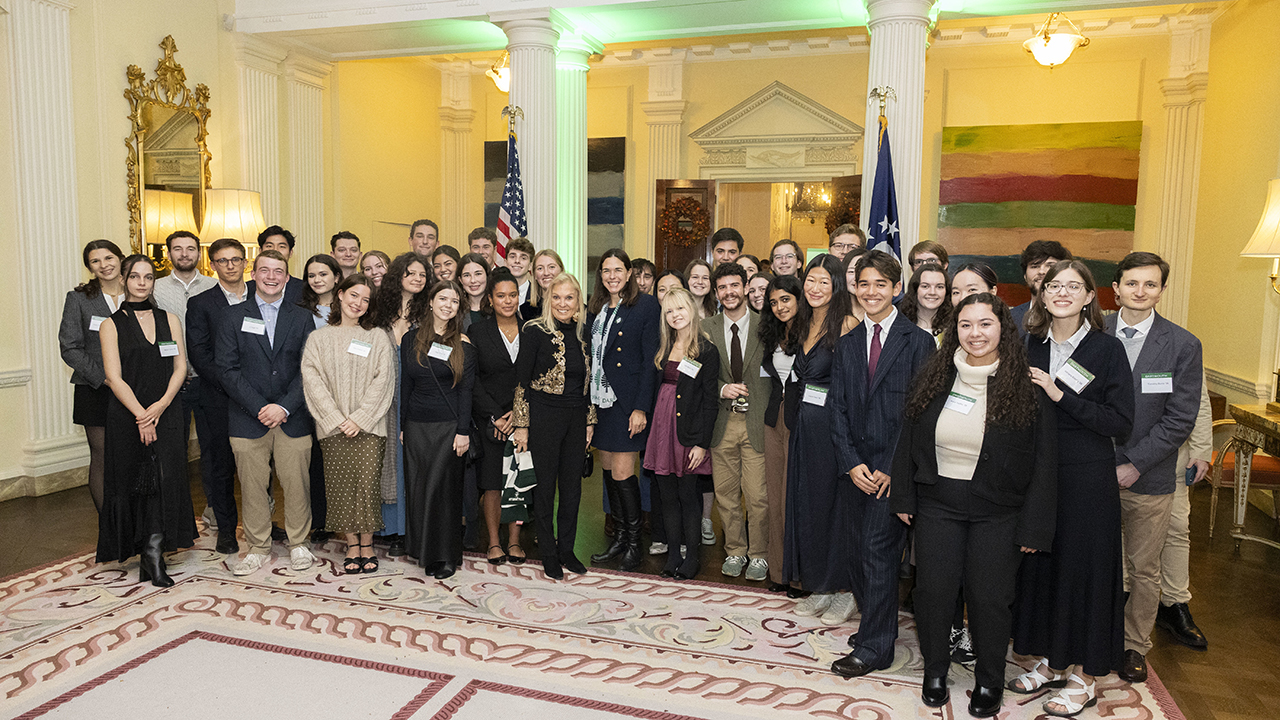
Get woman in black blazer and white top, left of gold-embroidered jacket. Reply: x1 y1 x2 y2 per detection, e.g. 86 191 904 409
467 268 525 565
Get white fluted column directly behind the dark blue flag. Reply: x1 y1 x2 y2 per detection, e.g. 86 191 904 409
863 0 933 252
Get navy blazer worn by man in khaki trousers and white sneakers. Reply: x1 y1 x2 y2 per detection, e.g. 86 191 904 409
215 288 316 438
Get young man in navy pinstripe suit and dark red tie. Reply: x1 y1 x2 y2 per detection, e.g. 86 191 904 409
828 250 937 678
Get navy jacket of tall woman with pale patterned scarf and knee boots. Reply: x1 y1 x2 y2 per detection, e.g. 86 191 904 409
582 293 662 414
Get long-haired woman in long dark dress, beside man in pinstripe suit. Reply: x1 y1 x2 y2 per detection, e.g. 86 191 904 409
782 252 858 624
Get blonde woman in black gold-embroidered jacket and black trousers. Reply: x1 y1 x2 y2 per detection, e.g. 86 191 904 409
511 273 595 580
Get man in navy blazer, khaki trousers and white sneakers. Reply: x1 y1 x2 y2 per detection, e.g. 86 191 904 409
216 250 315 575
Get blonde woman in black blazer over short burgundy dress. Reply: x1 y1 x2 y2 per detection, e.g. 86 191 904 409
644 290 719 580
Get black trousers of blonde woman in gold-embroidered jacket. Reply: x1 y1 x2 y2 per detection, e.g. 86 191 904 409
529 395 586 562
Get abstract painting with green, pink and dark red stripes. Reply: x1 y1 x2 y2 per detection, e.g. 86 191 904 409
938 120 1142 305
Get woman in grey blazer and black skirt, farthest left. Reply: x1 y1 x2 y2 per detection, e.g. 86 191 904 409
58 240 124 512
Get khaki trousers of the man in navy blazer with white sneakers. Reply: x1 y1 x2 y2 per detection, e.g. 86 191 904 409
232 427 311 555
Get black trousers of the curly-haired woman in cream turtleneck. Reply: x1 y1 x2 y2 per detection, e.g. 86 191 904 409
913 478 1023 688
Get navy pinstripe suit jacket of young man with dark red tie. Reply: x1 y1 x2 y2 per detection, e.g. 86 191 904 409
827 313 937 475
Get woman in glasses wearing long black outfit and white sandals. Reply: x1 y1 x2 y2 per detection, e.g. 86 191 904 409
1009 260 1134 716
